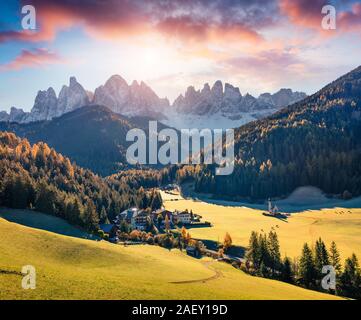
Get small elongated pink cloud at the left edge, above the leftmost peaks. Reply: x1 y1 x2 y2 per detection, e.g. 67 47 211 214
0 48 63 71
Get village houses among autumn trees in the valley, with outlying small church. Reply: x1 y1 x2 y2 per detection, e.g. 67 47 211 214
99 184 289 263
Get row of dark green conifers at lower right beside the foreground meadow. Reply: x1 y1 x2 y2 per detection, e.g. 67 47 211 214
242 230 361 299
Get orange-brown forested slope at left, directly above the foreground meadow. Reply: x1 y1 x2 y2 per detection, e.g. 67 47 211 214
0 132 161 231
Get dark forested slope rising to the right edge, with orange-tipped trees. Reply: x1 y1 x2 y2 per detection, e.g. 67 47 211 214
194 67 361 199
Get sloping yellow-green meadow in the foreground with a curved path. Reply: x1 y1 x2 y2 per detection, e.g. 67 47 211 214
0 214 336 300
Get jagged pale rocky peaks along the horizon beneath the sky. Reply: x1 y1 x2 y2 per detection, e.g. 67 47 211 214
0 75 306 128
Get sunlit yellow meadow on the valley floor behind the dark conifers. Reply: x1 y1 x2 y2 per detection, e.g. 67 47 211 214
162 192 361 259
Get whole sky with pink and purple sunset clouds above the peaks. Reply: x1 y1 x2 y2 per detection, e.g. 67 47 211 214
0 0 361 111
